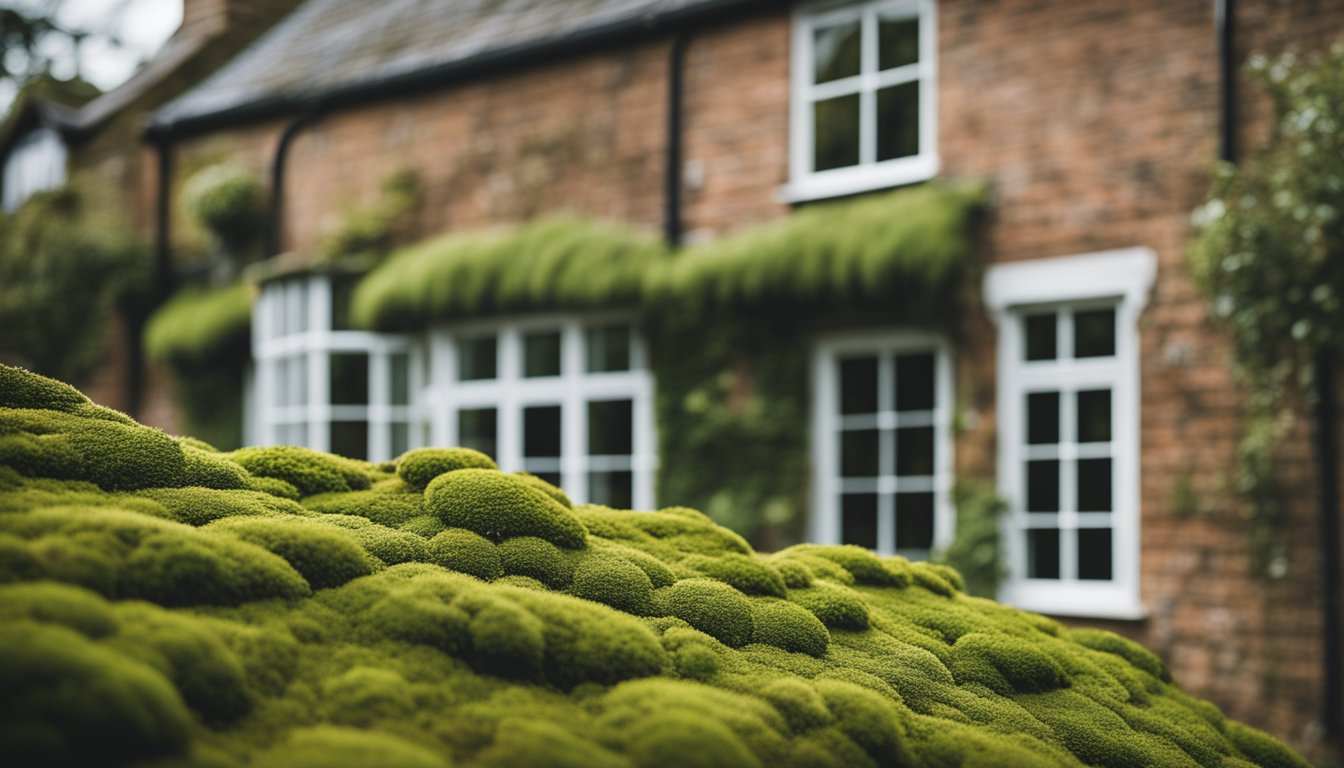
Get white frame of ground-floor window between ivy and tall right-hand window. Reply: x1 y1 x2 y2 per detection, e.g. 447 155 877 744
809 331 957 554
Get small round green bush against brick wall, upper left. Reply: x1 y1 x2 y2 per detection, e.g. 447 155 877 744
181 163 266 256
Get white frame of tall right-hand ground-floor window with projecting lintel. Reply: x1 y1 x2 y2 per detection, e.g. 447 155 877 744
984 247 1157 619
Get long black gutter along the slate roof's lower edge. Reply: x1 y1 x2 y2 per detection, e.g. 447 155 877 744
145 0 781 139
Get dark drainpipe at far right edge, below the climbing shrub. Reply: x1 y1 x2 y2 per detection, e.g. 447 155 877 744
1313 350 1344 740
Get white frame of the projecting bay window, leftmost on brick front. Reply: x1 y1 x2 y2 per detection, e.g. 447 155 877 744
247 273 422 461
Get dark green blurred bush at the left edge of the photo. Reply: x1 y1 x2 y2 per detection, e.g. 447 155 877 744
0 187 149 381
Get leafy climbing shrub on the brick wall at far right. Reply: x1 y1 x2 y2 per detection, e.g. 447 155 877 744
1189 47 1344 577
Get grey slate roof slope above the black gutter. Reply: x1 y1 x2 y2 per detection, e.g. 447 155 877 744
153 0 769 126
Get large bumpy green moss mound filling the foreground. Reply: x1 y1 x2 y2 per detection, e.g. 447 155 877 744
0 367 1305 768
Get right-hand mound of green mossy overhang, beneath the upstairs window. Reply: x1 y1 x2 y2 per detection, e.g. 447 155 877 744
653 184 986 308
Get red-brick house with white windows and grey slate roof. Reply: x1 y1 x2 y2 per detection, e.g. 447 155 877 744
39 0 1344 756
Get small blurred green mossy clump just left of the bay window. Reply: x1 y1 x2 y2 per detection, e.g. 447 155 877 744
145 282 253 363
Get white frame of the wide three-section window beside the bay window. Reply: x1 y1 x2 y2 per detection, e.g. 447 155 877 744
417 313 657 510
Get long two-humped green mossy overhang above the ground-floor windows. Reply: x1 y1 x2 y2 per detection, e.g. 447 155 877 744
353 183 986 331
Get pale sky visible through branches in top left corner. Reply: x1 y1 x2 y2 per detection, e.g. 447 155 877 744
0 0 181 113
